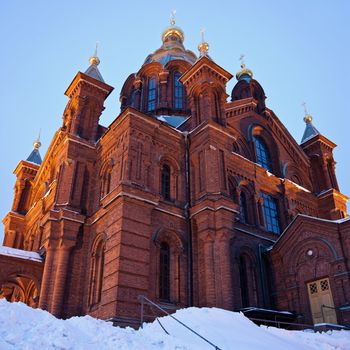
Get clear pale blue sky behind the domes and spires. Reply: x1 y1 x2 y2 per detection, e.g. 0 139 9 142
0 0 350 241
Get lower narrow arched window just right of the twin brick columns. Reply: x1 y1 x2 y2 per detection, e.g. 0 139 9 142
89 239 105 306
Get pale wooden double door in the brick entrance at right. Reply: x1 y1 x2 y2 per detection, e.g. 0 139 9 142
307 278 337 324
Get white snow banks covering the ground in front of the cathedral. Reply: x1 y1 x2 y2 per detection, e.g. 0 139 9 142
0 299 350 350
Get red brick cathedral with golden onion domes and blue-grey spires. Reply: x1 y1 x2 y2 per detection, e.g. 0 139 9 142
0 19 350 324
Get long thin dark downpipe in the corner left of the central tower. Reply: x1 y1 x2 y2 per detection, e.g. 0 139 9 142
183 131 193 306
